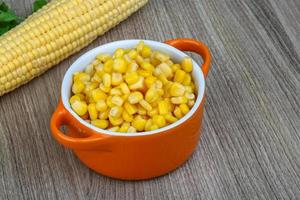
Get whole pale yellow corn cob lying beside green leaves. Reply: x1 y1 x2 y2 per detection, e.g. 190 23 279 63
0 0 148 96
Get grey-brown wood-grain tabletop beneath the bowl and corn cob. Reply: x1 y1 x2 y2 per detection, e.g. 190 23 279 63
0 0 300 200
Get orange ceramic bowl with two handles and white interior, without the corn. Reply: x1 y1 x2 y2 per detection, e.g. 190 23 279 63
50 39 211 180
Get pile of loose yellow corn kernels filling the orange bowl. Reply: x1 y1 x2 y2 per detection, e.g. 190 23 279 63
70 41 196 133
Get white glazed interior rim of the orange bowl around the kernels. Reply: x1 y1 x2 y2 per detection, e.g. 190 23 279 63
61 40 205 136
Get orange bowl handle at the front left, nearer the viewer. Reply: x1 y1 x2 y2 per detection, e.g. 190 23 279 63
50 100 109 151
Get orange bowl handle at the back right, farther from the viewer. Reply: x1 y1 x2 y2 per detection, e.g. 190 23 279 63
165 38 211 78
